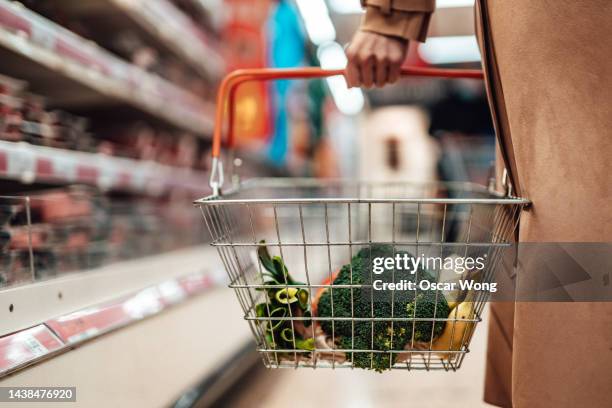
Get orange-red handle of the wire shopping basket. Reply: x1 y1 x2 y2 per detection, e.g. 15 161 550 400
209 67 484 195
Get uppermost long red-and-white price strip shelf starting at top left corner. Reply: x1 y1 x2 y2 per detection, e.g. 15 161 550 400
0 0 214 136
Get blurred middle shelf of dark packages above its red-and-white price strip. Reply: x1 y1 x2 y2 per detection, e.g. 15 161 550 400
0 70 205 195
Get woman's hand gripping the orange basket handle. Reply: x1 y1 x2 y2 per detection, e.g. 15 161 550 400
345 31 409 88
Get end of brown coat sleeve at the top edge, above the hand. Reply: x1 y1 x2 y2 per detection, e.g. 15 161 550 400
360 0 436 42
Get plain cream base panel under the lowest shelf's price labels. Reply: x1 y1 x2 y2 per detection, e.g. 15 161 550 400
1 289 252 408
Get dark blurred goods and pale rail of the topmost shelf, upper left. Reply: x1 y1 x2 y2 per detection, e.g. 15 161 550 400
20 0 223 89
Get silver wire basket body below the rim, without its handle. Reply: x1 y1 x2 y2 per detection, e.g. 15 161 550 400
196 179 528 371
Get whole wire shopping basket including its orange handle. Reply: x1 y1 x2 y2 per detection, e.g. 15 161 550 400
195 69 529 371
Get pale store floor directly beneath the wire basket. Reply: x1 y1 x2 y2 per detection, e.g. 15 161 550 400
218 308 491 408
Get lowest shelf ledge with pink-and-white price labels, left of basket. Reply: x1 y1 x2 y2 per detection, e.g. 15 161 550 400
0 247 226 378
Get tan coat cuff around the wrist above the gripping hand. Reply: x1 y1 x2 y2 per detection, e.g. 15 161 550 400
360 4 431 42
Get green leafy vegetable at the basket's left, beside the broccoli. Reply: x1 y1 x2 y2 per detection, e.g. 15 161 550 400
255 241 314 351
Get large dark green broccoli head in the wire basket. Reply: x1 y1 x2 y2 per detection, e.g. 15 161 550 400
318 244 449 372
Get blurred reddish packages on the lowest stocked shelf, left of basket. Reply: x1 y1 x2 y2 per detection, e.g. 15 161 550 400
0 187 206 287
